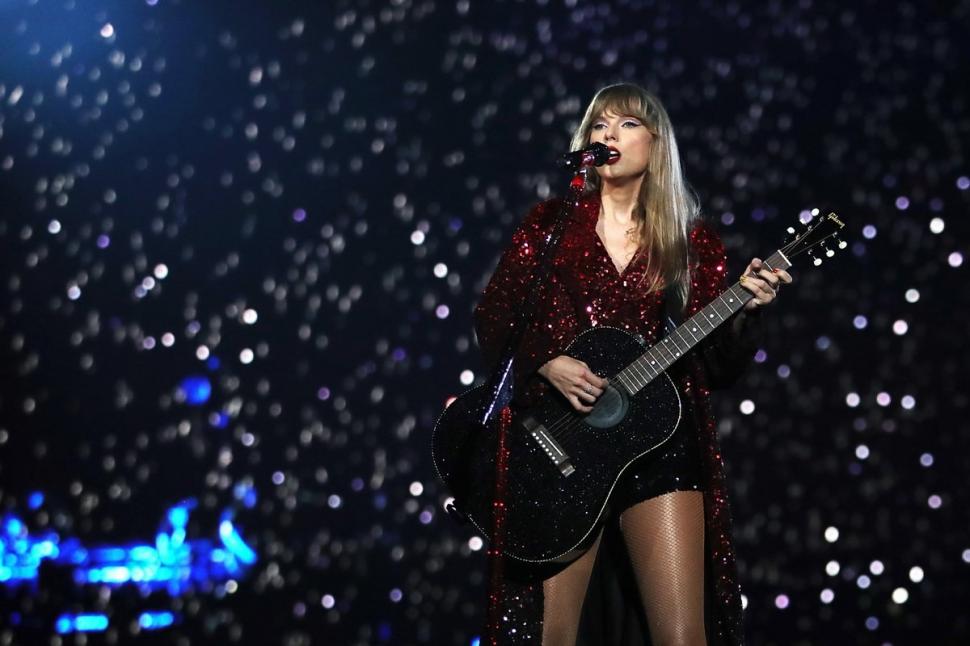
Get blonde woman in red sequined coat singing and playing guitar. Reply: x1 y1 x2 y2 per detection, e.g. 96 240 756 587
475 84 792 646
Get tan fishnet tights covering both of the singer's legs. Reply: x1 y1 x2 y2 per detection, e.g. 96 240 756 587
542 491 707 646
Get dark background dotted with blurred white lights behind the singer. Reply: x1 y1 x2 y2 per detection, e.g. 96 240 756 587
0 0 970 644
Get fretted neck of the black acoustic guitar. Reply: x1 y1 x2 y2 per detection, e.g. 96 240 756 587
615 251 791 395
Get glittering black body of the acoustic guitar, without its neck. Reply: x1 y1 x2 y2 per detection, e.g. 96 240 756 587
432 327 682 563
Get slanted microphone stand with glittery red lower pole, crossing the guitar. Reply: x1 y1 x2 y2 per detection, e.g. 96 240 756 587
480 165 588 646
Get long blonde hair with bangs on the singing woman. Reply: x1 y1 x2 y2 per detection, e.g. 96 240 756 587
570 83 700 306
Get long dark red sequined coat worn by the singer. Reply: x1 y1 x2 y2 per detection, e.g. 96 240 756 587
475 194 758 645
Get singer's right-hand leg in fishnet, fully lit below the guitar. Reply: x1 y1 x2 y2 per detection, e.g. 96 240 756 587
620 491 707 646
